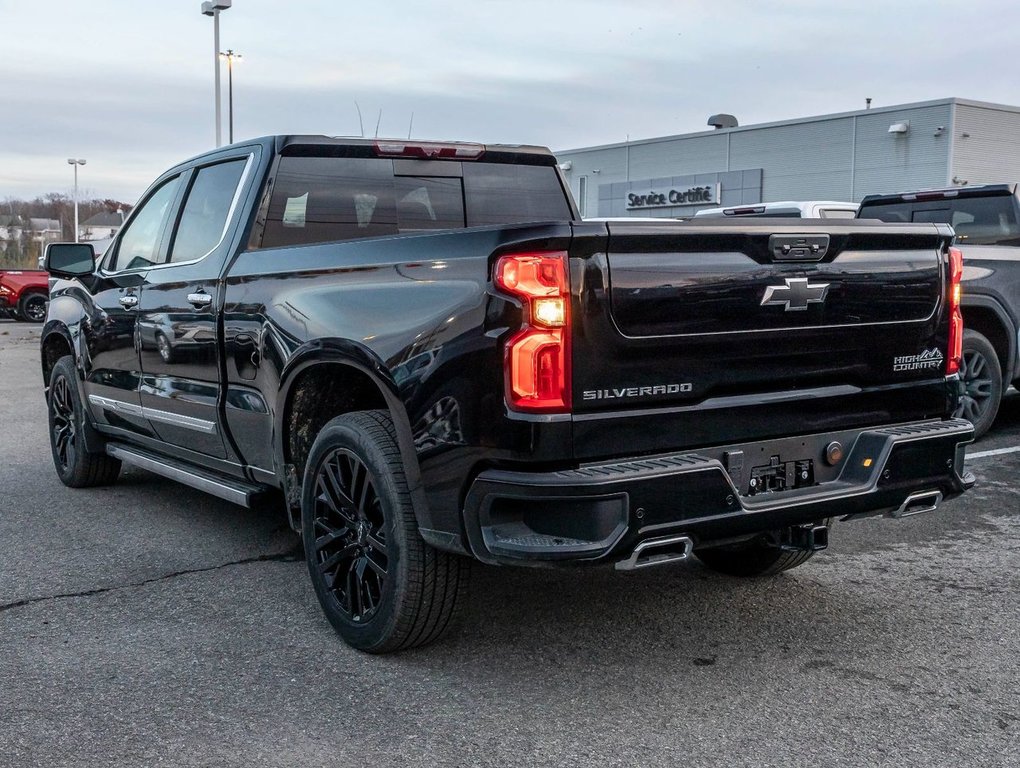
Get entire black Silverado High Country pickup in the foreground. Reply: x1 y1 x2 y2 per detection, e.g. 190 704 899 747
42 136 973 653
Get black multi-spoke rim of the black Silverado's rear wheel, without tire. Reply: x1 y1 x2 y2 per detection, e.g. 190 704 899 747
312 448 389 622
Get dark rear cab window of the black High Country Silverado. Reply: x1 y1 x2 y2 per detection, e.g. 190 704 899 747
262 156 571 248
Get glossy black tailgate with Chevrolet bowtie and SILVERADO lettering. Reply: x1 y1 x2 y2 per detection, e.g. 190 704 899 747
571 219 953 458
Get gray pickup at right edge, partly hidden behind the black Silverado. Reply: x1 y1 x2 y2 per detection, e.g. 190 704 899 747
858 184 1020 438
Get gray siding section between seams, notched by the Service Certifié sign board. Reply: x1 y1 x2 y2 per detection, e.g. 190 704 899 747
729 117 853 202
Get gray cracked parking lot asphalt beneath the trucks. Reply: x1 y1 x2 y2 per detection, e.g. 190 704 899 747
0 320 1020 766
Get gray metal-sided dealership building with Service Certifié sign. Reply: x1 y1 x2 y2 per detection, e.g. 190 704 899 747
556 98 1020 217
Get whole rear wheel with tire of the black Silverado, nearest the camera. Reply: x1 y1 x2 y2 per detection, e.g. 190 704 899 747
301 411 470 654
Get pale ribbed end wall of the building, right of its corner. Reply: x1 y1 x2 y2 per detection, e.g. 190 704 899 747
947 104 1020 185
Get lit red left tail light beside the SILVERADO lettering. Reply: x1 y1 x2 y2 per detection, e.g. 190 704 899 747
495 251 570 413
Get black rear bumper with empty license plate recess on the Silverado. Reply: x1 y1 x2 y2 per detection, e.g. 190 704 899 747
464 419 973 565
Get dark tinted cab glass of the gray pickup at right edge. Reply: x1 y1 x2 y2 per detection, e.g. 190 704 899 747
858 195 1020 245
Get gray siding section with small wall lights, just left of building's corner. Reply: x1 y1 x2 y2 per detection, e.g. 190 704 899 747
853 103 952 197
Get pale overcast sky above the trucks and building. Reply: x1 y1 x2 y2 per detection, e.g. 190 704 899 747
0 0 1020 202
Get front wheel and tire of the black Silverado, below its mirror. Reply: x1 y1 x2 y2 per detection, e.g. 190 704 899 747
47 355 120 488
